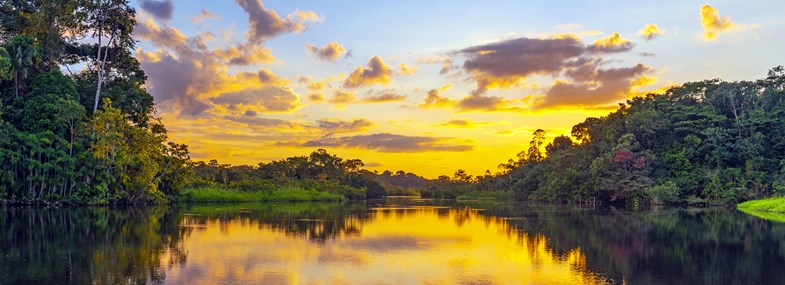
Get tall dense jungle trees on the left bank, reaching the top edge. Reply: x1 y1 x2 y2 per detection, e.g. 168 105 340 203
0 0 190 204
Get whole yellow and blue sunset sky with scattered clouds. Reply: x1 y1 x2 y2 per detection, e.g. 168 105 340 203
135 0 785 178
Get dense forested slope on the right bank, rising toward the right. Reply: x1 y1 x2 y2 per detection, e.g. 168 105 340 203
432 67 785 203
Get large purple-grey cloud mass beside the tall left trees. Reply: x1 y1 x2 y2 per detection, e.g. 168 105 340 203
134 14 298 116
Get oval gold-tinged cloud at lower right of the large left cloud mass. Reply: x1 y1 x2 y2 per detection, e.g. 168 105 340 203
210 87 300 112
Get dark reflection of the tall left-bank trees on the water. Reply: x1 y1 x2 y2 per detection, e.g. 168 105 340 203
0 208 187 284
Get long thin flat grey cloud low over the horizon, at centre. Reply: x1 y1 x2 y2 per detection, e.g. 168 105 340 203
302 133 474 153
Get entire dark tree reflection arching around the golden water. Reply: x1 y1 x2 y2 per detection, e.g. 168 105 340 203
0 201 785 284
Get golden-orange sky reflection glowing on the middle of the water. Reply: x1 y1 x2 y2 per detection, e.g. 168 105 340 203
166 207 606 284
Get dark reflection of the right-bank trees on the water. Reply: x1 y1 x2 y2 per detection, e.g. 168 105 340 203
484 205 785 284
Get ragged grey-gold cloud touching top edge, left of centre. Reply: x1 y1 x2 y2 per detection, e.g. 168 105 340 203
236 0 319 43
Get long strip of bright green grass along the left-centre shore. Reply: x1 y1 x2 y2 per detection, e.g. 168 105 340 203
177 187 344 203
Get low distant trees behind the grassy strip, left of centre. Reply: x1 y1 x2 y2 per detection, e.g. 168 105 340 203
190 149 387 200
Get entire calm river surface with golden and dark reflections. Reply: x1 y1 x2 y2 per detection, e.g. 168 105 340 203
0 199 785 284
